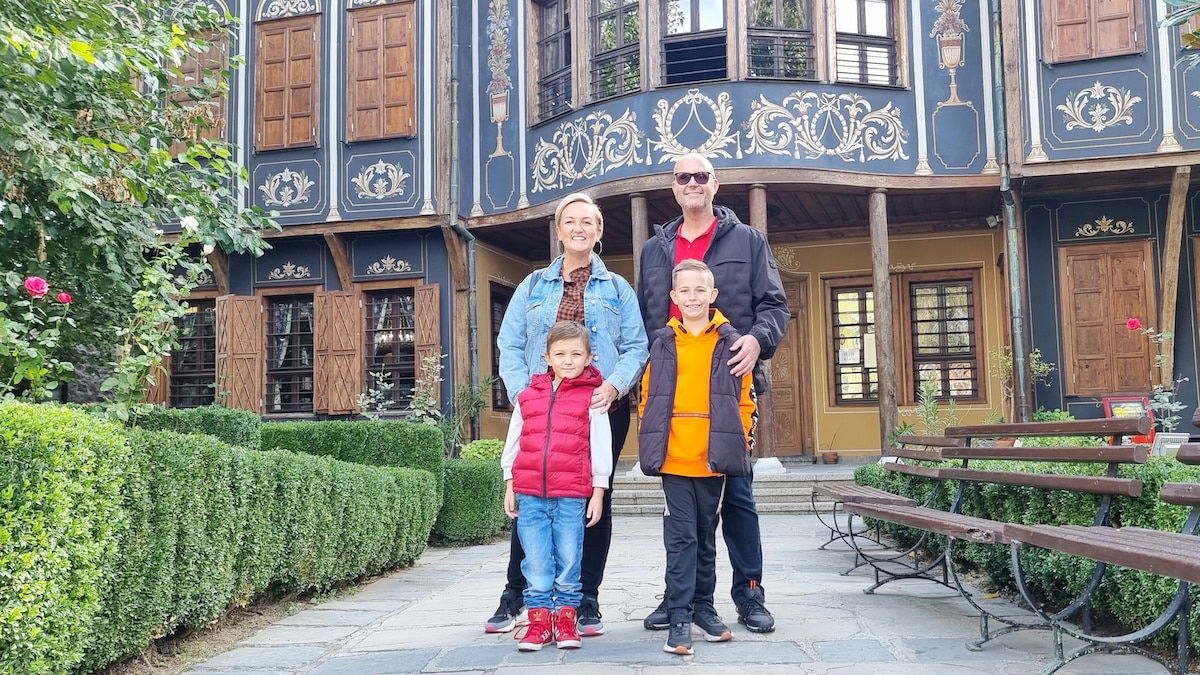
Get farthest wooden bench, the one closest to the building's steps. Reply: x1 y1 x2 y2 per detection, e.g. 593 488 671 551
810 436 964 564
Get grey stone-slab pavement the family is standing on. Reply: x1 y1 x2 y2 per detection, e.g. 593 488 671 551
188 515 1163 675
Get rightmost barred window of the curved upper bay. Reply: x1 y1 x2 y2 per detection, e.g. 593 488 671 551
830 0 900 85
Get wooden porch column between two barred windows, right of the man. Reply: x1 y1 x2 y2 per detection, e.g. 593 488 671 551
869 187 898 449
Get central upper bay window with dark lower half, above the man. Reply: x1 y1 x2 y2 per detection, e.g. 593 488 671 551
662 0 728 84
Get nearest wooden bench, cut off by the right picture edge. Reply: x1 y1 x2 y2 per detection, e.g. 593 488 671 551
1004 443 1200 675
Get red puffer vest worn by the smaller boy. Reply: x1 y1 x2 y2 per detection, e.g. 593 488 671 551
512 365 604 497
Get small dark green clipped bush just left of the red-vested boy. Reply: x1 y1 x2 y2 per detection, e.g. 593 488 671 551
433 459 509 543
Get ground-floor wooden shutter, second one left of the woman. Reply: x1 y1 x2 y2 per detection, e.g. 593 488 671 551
313 291 362 414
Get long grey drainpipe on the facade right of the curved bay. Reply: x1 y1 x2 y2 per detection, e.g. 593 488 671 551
991 0 1030 422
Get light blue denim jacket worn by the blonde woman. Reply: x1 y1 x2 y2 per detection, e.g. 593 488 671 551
497 256 649 400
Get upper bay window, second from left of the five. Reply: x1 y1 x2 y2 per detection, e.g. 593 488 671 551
590 0 642 101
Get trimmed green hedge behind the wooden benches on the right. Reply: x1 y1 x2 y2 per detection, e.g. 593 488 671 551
854 456 1200 649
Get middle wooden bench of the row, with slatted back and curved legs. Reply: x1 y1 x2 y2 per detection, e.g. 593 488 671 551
842 418 1151 650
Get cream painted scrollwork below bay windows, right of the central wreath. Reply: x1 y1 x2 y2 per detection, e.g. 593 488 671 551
746 90 908 162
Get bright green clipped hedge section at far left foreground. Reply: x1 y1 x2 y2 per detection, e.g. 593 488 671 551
0 402 130 673
